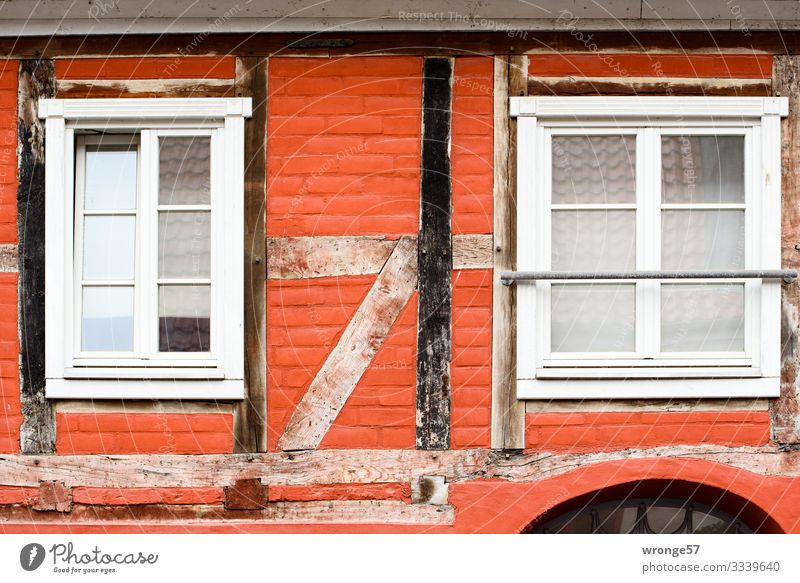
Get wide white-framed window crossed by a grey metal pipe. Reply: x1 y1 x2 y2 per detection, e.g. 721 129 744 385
509 97 788 399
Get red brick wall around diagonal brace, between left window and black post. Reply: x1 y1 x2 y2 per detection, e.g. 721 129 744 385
267 57 422 449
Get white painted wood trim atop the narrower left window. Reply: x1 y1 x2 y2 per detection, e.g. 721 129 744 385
39 97 253 120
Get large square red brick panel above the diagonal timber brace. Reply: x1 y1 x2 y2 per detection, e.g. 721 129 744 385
267 57 422 237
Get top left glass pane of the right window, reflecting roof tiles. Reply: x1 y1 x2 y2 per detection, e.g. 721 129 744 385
552 136 636 204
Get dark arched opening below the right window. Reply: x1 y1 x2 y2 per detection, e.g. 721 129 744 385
522 480 782 534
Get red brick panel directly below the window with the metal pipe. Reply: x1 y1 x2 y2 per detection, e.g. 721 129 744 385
525 411 770 453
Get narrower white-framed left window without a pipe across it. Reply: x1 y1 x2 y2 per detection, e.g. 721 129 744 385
40 99 251 399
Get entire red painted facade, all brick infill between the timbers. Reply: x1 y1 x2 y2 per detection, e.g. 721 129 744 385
0 54 800 532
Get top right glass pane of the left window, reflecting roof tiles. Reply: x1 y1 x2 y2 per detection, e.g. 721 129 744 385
158 136 211 204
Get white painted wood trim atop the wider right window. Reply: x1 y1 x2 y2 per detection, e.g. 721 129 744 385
509 96 789 120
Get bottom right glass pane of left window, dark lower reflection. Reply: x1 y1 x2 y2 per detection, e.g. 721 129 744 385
158 285 211 352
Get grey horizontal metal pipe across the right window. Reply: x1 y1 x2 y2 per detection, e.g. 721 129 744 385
500 269 797 285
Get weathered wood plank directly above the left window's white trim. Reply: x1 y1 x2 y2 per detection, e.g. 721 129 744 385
56 79 234 99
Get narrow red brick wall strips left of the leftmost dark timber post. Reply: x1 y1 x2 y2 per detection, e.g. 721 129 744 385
0 61 22 453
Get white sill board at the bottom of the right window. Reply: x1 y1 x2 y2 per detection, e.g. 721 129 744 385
517 376 780 400
